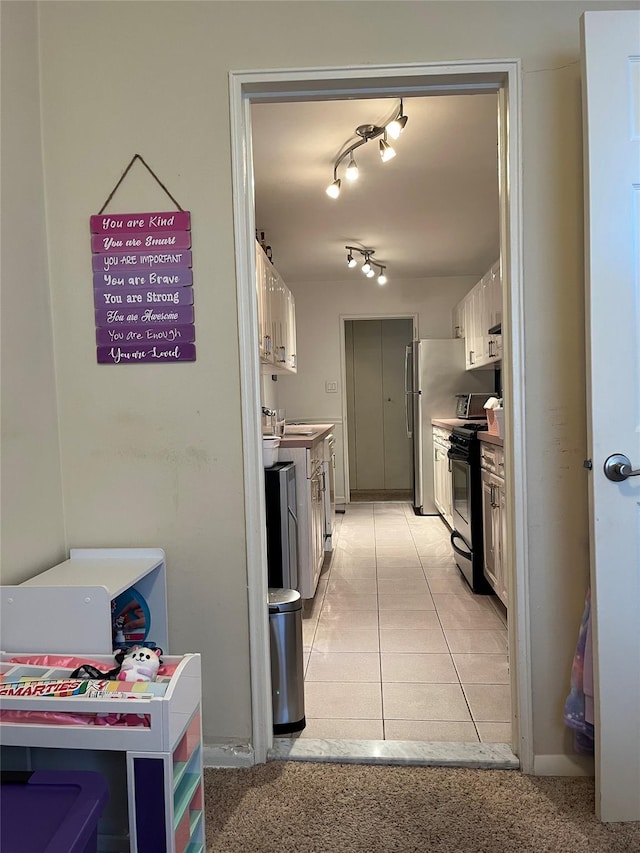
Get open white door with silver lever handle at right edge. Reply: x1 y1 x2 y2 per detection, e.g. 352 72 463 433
582 11 640 821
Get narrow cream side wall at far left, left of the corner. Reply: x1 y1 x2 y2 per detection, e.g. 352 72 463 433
0 2 67 584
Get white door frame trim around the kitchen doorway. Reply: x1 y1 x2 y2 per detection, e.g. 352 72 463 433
229 59 534 773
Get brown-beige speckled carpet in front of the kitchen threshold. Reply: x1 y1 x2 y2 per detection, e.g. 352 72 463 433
205 761 640 853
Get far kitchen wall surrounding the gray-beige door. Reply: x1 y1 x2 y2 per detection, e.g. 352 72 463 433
272 270 476 503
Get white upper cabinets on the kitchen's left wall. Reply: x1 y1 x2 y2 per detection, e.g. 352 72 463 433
256 243 297 373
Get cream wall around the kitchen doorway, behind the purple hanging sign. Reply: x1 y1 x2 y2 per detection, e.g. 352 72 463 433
2 0 636 755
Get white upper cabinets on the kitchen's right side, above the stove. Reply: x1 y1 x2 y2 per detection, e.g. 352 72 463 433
452 260 502 370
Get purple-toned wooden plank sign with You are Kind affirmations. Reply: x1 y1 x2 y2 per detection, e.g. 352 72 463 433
90 210 196 364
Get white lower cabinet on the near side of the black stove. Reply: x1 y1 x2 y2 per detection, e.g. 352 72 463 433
480 442 509 607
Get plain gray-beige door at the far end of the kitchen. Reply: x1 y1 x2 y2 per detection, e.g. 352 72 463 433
345 319 413 492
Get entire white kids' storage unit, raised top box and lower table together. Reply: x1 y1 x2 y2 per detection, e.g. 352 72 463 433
0 548 204 853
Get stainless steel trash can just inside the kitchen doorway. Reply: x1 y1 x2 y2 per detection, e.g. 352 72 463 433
269 589 306 735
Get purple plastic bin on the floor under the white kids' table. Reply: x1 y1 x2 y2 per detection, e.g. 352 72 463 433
0 770 109 853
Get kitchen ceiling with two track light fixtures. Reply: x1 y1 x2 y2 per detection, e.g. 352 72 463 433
251 94 499 285
